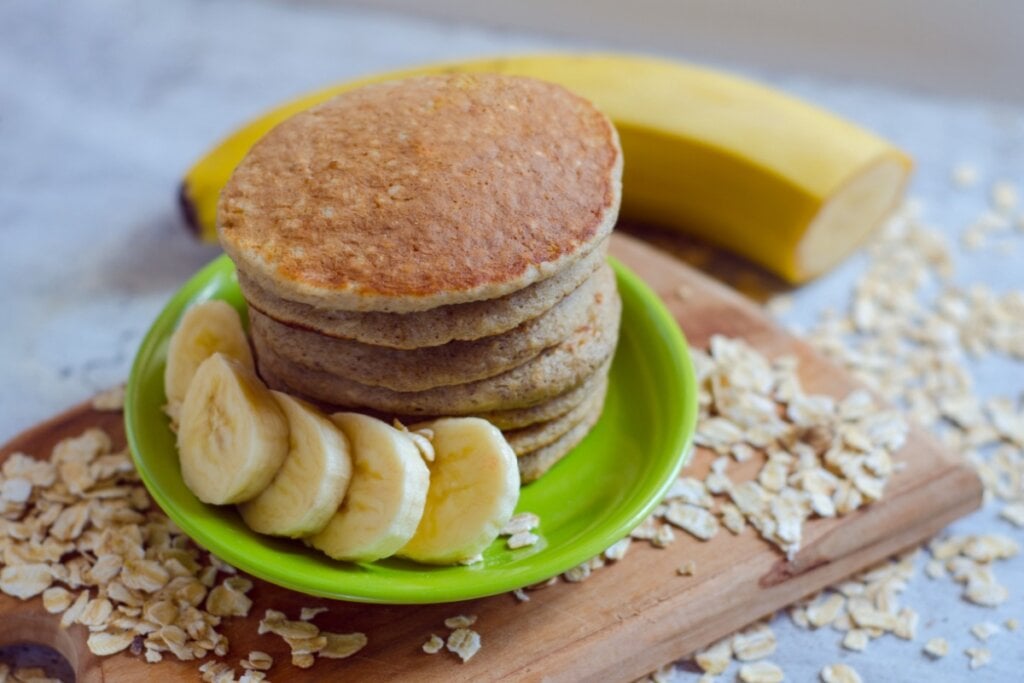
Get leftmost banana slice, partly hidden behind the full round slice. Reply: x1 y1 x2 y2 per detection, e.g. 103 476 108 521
164 299 255 405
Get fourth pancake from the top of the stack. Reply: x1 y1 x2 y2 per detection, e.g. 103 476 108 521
253 280 622 416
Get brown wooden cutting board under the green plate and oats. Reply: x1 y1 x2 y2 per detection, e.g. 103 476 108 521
0 234 982 682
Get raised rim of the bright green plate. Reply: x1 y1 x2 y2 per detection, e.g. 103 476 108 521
124 254 697 604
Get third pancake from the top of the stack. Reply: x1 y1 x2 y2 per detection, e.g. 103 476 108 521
250 265 615 391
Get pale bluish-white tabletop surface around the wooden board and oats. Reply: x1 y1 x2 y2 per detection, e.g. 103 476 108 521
0 0 1024 681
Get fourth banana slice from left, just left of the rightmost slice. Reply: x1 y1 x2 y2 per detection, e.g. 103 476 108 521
307 413 430 562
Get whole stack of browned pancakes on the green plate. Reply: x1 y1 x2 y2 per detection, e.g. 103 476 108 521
218 75 622 481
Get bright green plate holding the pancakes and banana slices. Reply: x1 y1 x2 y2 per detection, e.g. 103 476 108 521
119 256 696 604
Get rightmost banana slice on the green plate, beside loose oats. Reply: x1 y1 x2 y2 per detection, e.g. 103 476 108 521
398 418 519 564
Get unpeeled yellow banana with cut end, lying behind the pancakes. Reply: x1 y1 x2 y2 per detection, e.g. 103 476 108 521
180 54 911 283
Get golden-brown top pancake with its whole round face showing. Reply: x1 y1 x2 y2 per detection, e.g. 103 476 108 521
217 74 622 312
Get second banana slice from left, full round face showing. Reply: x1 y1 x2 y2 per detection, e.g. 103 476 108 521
178 352 288 505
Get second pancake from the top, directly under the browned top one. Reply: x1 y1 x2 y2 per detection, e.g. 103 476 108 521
238 240 608 349
